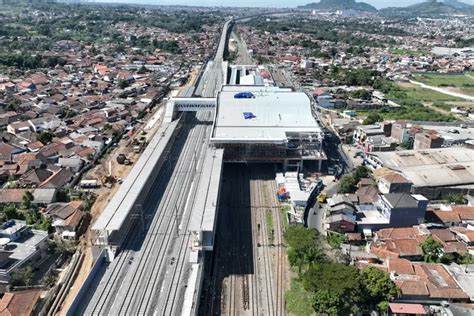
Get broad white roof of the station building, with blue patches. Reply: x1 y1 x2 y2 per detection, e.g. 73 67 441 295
211 86 321 143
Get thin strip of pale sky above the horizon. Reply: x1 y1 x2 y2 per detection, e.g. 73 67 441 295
90 0 474 9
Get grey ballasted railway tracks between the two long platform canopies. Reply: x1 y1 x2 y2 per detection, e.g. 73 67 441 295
86 112 210 315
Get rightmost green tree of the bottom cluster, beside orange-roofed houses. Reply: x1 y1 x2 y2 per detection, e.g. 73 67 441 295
362 267 399 310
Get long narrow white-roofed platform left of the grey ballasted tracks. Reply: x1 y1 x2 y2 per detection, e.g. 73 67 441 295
91 120 179 247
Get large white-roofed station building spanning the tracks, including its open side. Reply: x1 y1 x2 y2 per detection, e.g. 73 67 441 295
210 85 327 170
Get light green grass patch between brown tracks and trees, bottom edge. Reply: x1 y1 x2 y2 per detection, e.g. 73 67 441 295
285 279 316 316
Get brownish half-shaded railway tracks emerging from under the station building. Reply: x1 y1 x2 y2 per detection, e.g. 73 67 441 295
200 164 286 315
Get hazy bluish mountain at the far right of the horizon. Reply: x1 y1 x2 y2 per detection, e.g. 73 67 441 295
380 0 474 16
